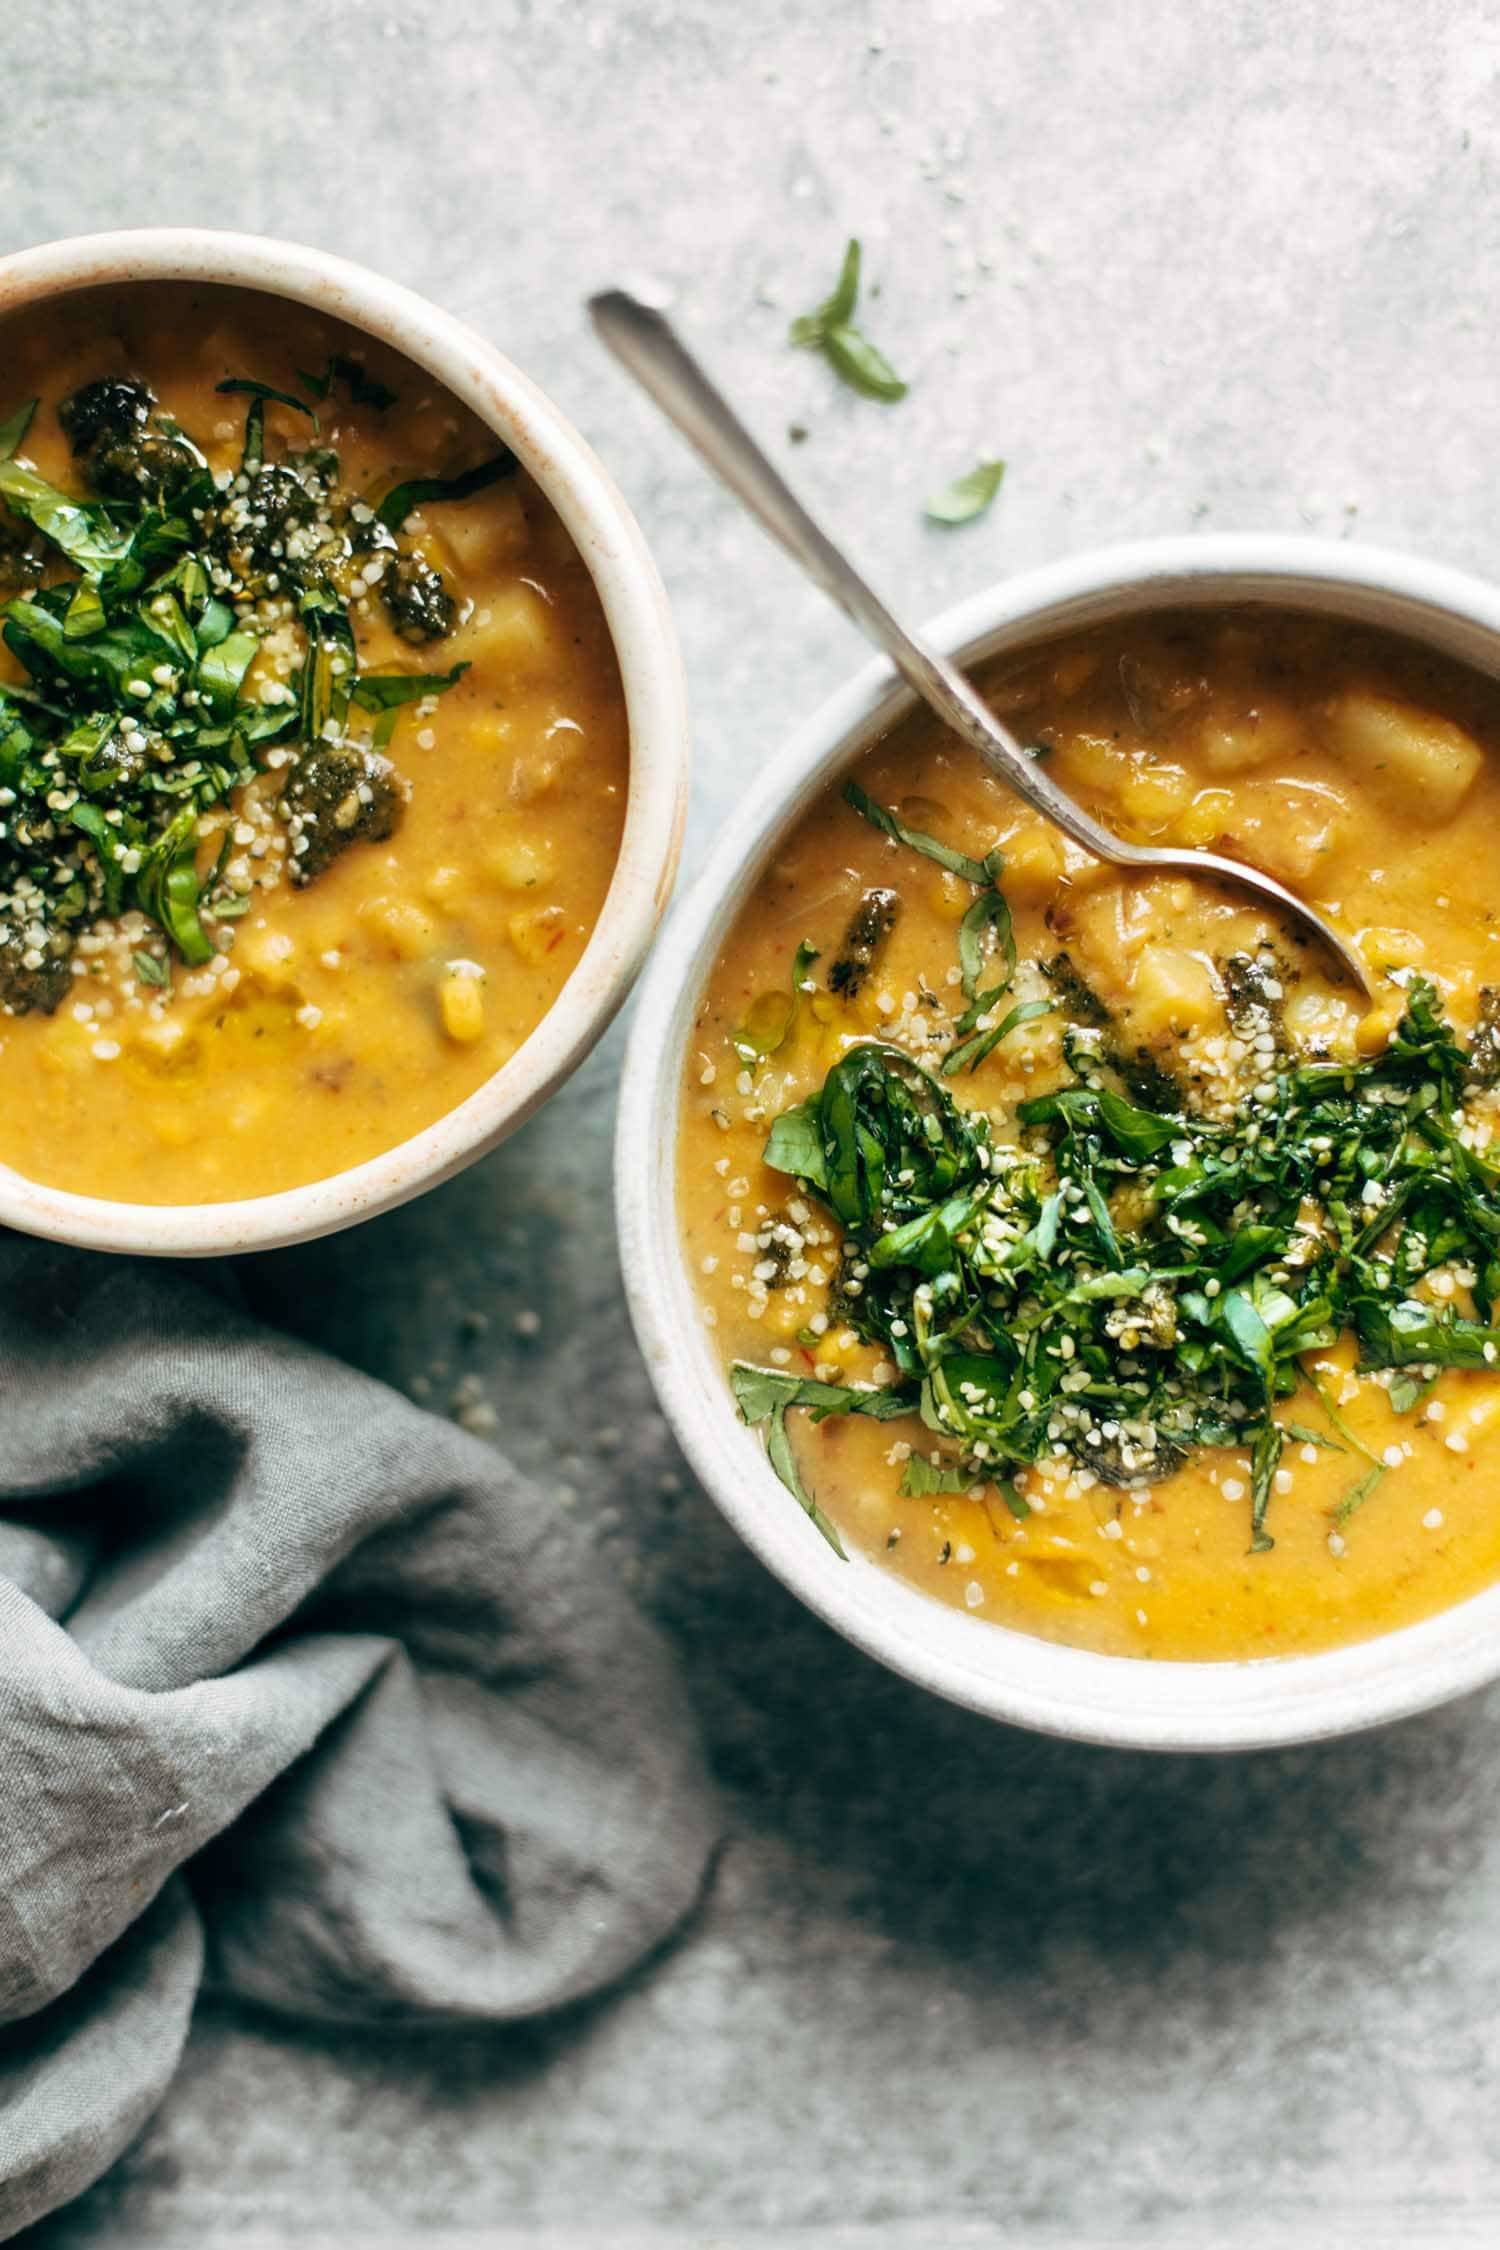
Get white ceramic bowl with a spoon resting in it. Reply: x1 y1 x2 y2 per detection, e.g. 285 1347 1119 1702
616 538 1500 1751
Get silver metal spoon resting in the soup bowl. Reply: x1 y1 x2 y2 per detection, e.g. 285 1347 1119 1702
589 288 1372 992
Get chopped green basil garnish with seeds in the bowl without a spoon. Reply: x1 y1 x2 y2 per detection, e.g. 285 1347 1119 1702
0 358 474 1013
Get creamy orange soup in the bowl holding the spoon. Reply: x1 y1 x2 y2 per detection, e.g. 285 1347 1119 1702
679 610 1500 1658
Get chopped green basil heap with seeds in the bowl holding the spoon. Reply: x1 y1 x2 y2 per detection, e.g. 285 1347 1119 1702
735 976 1500 1555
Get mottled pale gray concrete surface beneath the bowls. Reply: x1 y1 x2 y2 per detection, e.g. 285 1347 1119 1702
0 0 1500 2250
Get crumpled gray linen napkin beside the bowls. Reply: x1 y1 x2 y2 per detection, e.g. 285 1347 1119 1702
0 1238 713 2237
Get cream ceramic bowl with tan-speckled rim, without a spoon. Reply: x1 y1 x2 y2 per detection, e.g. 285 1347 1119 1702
0 227 688 1258
